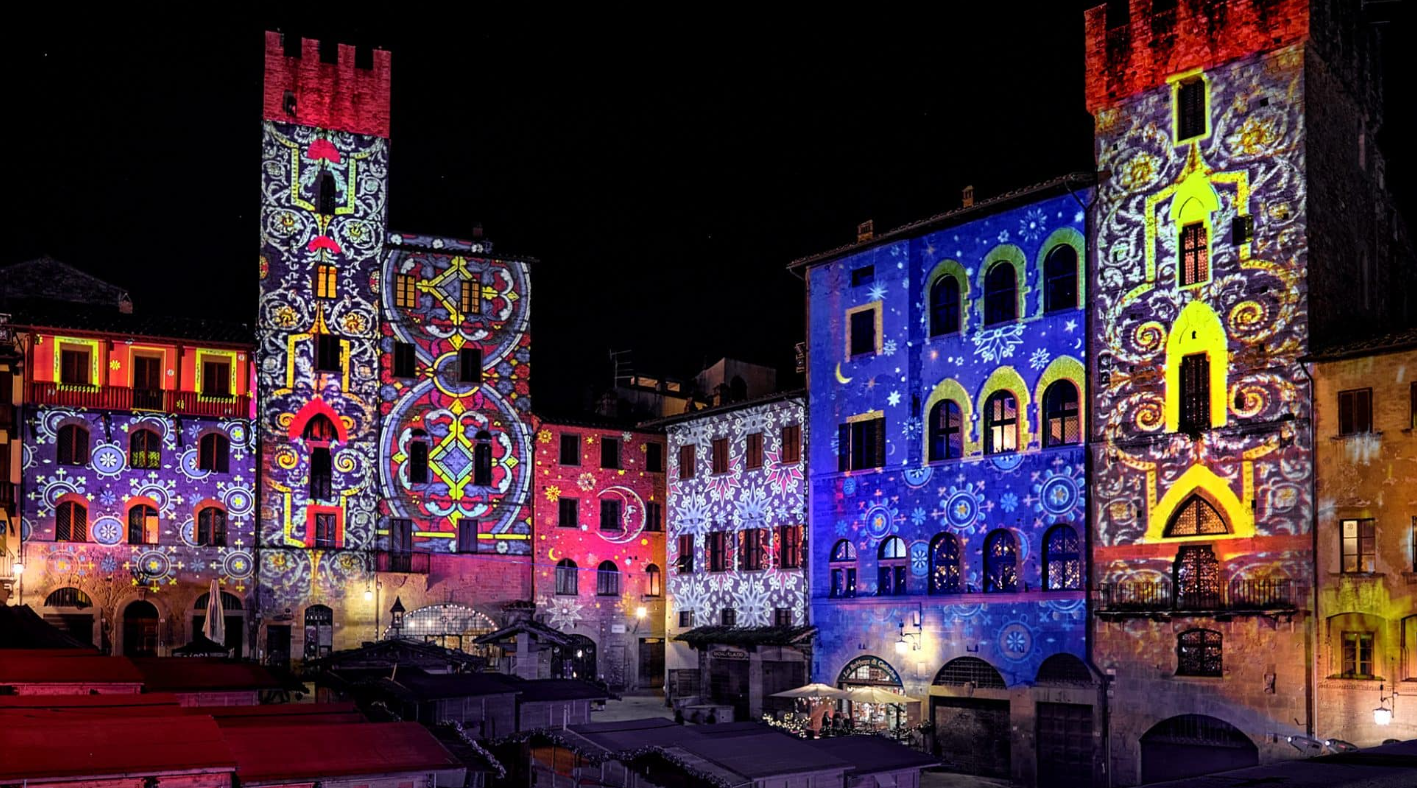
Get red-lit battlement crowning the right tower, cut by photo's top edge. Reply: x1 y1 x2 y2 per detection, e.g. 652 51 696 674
1085 0 1309 112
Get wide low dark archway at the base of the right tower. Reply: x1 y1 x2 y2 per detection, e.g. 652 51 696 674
1141 714 1260 782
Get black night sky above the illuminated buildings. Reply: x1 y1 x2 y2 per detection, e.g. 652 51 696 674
0 12 1417 410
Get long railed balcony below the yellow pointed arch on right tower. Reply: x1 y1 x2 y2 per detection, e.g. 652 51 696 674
1098 580 1304 618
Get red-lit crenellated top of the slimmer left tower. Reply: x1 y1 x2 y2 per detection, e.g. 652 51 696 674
262 31 390 137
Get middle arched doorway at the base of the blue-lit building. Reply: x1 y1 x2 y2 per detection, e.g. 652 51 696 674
930 656 1012 777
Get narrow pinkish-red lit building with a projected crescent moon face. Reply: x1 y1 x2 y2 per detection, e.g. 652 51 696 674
531 420 667 689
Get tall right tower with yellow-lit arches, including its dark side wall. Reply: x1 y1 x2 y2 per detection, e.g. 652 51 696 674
1087 0 1410 785
